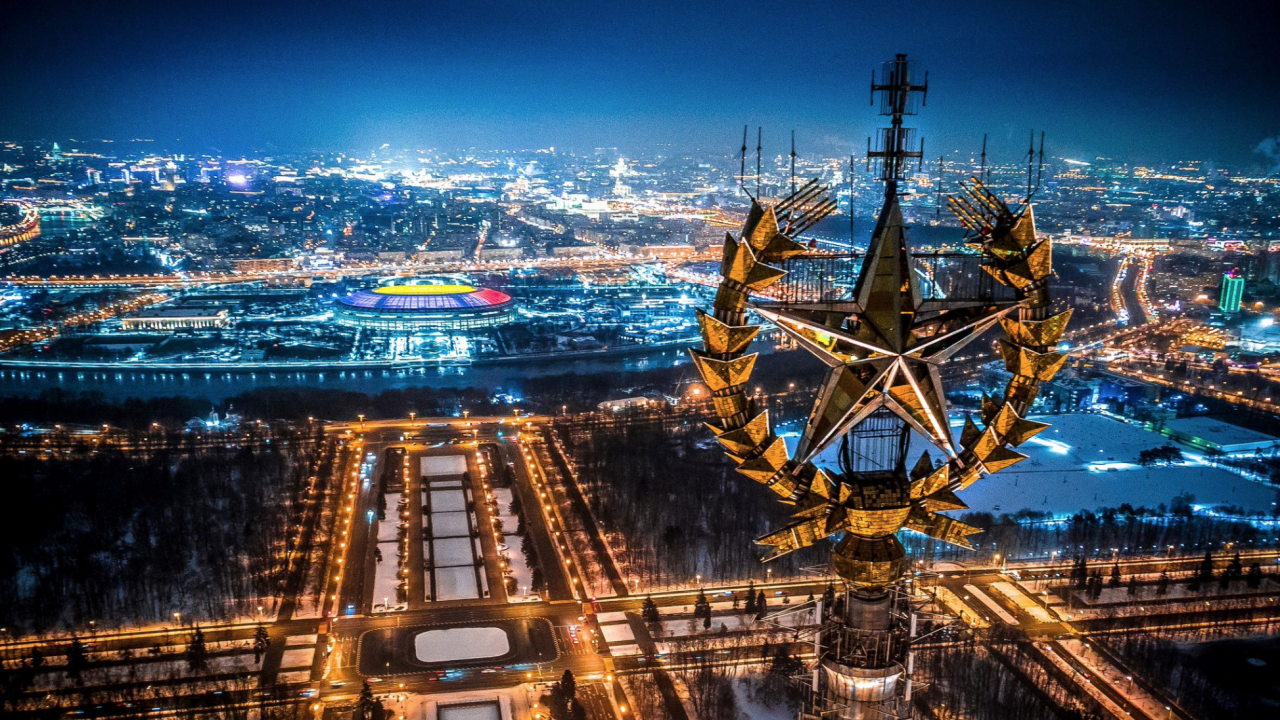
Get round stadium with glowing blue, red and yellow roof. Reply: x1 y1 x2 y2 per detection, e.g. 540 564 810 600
334 279 516 333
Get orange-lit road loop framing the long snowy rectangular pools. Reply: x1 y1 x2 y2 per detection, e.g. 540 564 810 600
316 416 617 720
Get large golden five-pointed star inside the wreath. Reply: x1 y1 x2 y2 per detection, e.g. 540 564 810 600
756 202 1016 462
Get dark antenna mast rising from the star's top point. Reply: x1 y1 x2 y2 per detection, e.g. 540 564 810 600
867 54 929 197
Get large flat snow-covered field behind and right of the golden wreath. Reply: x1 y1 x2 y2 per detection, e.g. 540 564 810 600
782 414 1276 514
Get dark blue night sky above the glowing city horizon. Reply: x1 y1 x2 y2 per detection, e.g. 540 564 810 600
0 0 1280 164
